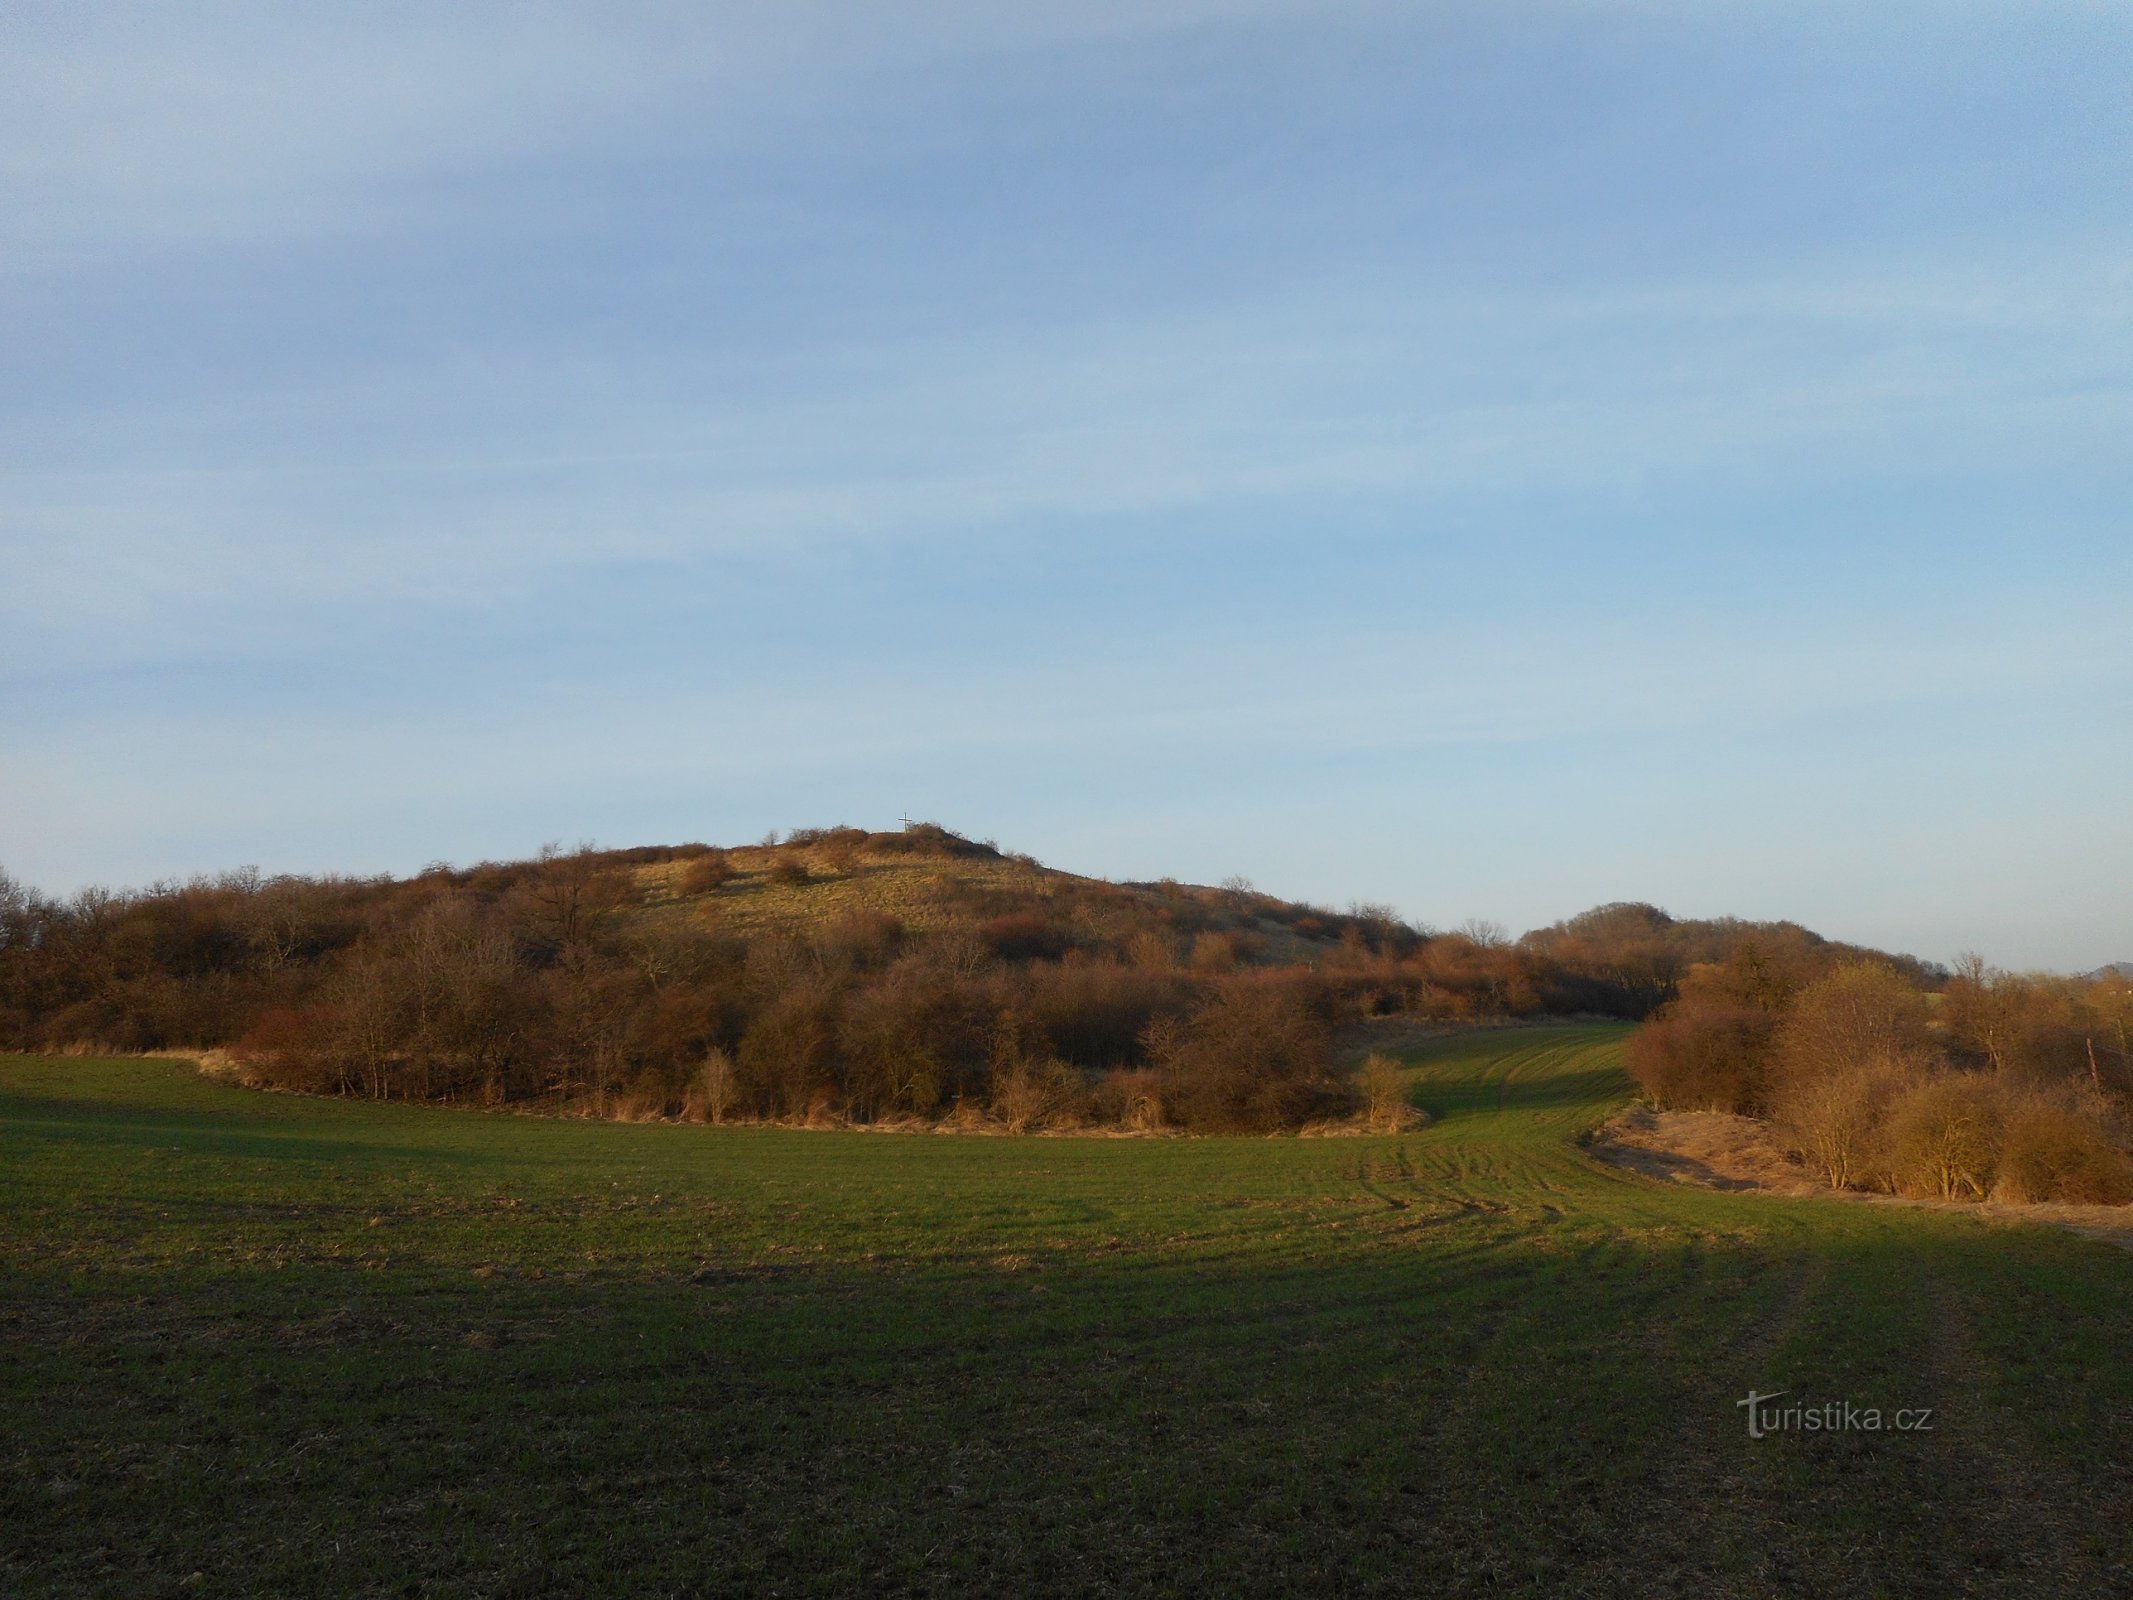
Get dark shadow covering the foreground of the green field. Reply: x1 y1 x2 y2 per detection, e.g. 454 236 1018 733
0 1216 2133 1596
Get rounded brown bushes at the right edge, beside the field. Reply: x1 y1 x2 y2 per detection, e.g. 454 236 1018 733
1630 941 2133 1205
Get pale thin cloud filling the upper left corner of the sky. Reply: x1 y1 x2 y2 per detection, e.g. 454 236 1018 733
0 0 1382 269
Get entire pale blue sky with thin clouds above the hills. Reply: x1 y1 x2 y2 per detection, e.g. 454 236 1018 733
0 0 2133 971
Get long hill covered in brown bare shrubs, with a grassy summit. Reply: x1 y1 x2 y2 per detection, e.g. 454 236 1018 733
0 823 1953 1131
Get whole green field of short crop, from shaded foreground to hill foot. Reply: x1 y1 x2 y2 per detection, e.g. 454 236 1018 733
0 1026 2133 1596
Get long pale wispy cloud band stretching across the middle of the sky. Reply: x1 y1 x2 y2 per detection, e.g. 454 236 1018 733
0 250 2133 653
